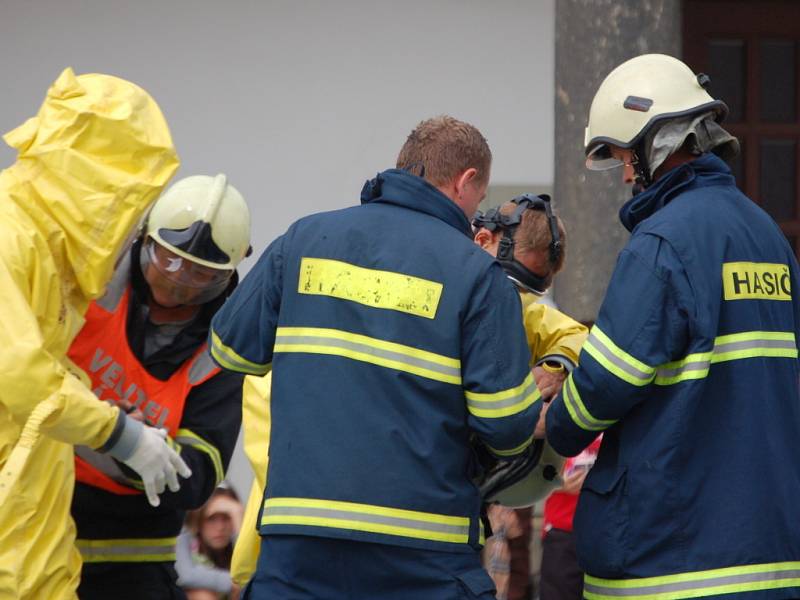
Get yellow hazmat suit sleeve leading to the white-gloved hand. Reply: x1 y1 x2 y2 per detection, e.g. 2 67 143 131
0 231 122 448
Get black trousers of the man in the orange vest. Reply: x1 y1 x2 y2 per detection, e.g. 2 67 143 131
78 562 186 600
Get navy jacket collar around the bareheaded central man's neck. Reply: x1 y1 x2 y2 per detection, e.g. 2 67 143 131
361 169 472 239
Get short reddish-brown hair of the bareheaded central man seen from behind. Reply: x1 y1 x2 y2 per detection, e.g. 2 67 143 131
397 115 492 186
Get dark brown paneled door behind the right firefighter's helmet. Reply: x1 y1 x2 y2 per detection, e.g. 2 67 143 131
683 0 800 254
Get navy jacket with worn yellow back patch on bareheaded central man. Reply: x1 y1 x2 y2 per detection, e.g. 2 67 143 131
211 170 541 552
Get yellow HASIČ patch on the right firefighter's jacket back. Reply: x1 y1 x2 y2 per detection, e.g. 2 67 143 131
722 262 792 300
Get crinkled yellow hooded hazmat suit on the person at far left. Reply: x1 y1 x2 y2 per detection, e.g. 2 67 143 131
0 69 178 600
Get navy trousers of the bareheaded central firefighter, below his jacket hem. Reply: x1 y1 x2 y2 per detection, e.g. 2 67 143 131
242 535 494 600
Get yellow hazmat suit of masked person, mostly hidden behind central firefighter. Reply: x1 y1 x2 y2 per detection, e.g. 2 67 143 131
231 293 589 586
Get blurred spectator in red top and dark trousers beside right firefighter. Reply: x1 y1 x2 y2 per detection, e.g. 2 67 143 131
539 435 603 600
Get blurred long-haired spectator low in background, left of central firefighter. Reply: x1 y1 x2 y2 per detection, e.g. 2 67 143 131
175 485 243 600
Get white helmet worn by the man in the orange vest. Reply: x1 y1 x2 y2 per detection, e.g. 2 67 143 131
145 174 250 270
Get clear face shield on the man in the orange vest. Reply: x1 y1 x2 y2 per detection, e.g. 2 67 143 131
139 238 233 308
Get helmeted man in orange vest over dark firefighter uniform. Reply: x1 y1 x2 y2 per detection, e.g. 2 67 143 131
69 175 250 599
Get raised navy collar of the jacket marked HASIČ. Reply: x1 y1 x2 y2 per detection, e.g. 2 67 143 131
619 153 734 231
